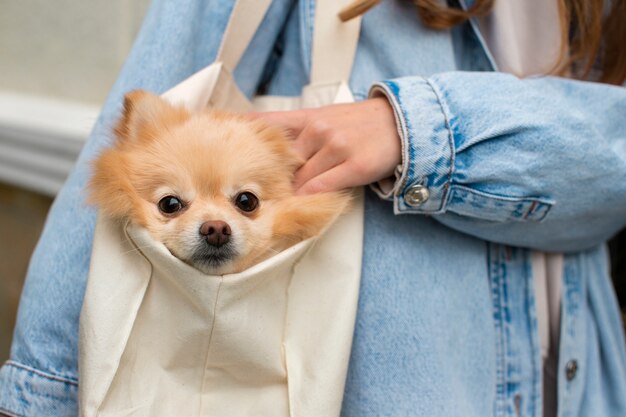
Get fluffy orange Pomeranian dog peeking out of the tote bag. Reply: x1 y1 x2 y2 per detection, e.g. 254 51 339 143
88 90 350 275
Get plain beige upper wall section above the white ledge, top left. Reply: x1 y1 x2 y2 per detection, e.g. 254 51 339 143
0 0 149 103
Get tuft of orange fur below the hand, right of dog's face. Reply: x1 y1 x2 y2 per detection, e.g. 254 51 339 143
273 192 352 242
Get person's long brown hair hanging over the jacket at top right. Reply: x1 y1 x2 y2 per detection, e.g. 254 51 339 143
413 0 626 85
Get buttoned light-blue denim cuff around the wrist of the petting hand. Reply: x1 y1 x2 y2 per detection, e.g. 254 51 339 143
369 77 454 214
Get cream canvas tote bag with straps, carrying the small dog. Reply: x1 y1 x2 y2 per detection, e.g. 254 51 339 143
79 0 363 417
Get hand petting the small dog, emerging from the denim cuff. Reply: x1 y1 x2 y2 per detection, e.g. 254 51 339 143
252 97 402 194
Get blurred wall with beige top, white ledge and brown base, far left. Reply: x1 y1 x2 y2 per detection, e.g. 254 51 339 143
0 0 149 363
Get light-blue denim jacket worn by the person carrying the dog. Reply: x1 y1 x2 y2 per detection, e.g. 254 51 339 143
0 0 626 417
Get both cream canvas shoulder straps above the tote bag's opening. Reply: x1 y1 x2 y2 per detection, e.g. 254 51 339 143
215 0 361 84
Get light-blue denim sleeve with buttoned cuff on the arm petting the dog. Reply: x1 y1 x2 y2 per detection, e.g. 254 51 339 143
370 72 626 251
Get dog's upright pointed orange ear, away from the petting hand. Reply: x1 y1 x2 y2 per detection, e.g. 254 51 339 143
115 90 189 143
